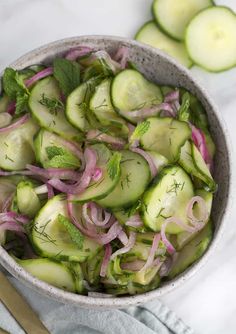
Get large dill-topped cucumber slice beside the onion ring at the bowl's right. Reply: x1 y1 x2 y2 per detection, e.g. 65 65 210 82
142 166 194 234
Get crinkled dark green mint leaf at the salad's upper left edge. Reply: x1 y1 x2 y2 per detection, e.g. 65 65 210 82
3 67 27 100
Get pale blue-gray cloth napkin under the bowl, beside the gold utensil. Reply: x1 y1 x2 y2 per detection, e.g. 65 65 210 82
0 277 194 334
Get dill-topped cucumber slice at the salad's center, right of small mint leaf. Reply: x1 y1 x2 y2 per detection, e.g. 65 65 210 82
97 151 151 211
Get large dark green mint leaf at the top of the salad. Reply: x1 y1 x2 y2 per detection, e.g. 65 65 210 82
53 58 80 96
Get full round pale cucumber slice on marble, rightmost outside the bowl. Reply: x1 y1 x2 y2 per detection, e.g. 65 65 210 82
185 6 236 72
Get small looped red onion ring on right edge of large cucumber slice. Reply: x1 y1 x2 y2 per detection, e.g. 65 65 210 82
186 196 209 232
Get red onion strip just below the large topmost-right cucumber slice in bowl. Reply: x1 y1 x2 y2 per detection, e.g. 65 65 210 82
125 102 175 120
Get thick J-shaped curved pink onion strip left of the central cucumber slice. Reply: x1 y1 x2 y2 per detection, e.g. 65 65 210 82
48 148 97 195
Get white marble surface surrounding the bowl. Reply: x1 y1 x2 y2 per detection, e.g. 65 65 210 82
0 0 236 334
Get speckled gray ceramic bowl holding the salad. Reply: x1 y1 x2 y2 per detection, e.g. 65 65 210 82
0 36 231 308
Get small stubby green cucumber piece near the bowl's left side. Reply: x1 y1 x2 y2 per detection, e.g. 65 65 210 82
16 181 41 218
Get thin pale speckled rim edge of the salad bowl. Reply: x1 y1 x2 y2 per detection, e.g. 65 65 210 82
0 35 233 309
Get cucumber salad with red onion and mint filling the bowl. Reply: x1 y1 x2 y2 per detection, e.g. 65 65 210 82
0 45 217 297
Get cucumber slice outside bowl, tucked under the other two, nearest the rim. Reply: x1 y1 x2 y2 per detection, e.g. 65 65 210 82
135 21 193 68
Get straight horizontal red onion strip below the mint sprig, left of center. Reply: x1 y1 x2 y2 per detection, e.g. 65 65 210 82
26 165 81 181
